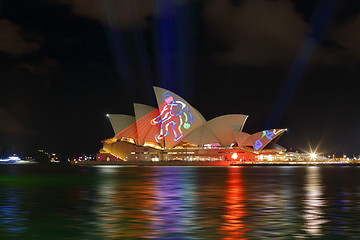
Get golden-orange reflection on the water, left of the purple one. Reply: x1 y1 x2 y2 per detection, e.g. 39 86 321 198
92 168 153 239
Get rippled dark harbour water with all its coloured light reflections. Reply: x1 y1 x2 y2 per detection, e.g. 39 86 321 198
0 165 360 240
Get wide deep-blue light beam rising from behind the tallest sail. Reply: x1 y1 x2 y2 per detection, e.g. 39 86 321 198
153 0 194 99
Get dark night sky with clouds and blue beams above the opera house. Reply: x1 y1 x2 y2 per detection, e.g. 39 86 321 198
0 0 360 154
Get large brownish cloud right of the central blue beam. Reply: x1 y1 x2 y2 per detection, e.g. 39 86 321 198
204 0 308 66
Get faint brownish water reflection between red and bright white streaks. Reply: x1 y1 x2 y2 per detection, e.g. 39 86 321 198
243 167 299 239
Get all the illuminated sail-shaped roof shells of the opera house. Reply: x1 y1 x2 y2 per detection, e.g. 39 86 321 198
104 87 286 151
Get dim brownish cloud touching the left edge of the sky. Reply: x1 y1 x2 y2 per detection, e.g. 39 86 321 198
0 19 40 56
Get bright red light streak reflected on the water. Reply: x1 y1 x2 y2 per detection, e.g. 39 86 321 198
220 167 248 240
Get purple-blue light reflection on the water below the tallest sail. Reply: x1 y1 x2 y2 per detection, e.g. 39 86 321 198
148 167 197 239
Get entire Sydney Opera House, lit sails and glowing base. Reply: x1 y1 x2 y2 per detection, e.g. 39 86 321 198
97 87 286 162
